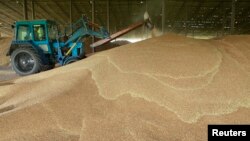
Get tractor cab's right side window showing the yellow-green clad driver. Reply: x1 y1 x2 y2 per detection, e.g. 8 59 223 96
33 24 46 41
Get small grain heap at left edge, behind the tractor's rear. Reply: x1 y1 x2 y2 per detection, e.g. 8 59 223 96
0 37 12 66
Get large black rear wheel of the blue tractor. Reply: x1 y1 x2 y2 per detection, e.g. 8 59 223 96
11 47 42 76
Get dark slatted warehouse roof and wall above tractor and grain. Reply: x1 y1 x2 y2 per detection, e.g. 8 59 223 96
0 0 250 36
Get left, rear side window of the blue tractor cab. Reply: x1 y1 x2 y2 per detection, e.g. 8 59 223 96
17 25 31 41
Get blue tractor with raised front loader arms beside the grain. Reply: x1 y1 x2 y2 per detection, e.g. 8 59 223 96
7 17 109 76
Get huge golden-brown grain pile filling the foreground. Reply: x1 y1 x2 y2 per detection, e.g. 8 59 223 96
0 34 250 141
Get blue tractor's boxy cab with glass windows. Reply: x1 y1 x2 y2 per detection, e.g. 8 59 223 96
14 20 58 54
